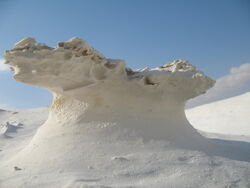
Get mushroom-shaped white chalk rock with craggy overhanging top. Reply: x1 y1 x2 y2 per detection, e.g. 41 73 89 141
5 38 214 163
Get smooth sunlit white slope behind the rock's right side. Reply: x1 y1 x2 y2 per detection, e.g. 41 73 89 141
186 93 250 135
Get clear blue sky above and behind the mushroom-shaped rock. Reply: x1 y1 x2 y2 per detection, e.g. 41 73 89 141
0 0 250 109
